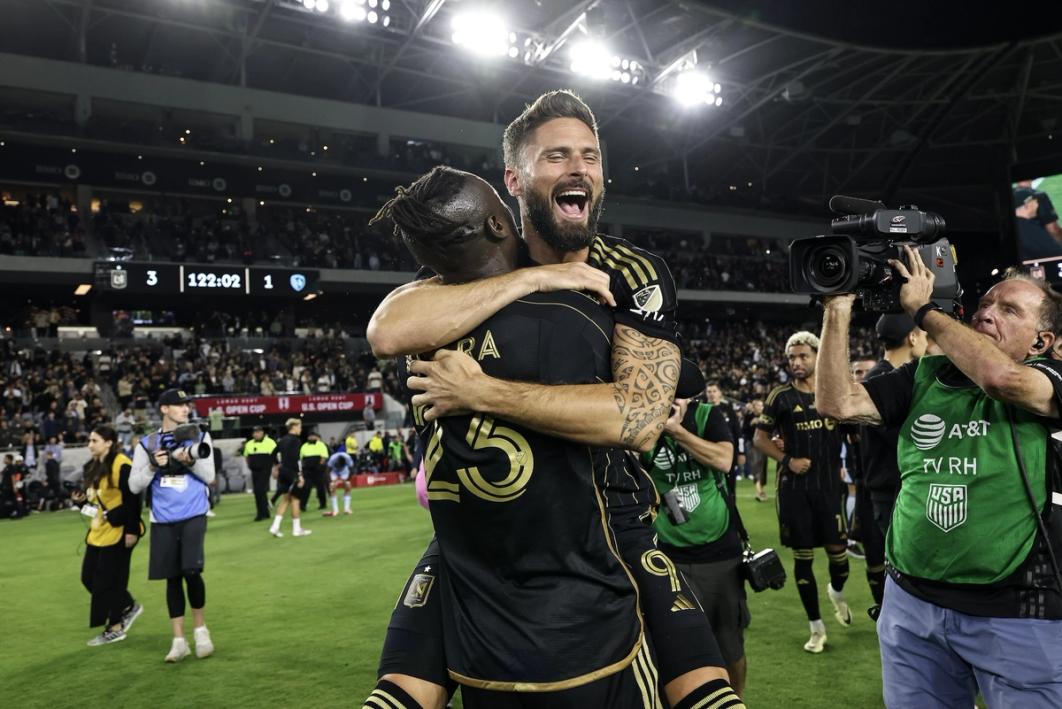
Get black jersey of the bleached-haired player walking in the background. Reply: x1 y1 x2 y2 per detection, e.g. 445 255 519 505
756 384 841 491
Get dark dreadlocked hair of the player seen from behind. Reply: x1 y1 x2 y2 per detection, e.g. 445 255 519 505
369 165 477 253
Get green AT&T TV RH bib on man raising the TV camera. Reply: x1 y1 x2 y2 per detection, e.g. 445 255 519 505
886 356 1048 584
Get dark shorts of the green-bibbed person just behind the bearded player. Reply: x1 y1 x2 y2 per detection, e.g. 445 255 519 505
675 556 751 664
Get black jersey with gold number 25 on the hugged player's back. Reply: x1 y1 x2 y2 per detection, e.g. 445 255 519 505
414 291 641 691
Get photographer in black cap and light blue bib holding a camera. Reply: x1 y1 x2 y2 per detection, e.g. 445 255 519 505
130 388 215 662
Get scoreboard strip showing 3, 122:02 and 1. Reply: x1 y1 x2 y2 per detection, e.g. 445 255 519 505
96 261 320 298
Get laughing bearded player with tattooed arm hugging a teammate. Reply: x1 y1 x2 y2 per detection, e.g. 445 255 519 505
369 91 739 703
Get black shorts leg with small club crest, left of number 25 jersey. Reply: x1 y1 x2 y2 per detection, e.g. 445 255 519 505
376 539 457 694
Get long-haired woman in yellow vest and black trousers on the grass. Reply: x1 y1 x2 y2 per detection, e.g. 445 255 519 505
78 426 144 647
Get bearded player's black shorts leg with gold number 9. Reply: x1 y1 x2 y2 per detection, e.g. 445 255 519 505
611 519 724 683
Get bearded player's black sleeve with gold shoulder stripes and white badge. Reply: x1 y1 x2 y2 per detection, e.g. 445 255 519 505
587 237 679 344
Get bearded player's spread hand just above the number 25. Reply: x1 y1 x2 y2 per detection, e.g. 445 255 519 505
406 349 487 421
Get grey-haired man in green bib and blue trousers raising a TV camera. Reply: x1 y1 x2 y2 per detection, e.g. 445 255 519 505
817 245 1062 707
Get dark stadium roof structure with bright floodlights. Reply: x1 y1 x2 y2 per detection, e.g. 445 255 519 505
0 0 1062 230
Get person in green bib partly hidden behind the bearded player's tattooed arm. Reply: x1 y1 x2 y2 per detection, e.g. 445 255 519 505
641 360 750 696
